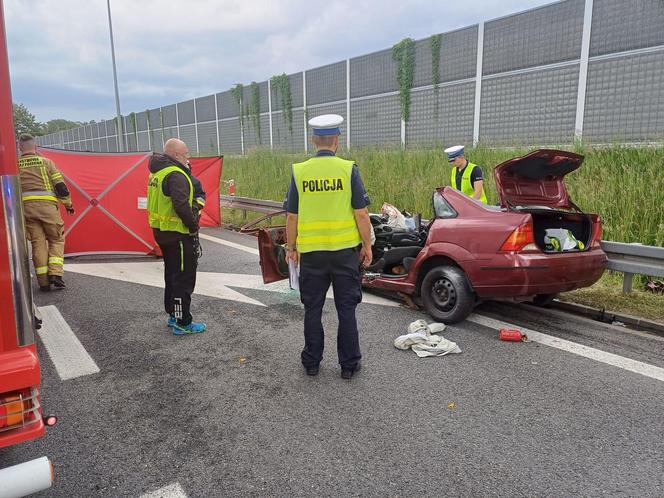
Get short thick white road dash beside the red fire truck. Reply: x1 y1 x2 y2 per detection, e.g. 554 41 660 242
38 306 99 380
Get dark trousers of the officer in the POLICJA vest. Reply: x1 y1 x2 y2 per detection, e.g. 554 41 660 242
300 248 362 369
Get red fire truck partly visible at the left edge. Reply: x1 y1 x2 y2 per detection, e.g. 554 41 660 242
0 0 56 497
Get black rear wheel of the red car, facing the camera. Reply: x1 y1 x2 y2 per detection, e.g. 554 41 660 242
421 266 475 323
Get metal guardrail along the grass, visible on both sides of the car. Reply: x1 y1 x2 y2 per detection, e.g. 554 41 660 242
219 195 664 294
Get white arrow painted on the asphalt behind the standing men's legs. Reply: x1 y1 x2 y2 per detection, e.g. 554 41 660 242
67 261 399 307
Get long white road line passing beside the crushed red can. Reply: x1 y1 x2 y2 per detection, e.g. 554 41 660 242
467 314 664 382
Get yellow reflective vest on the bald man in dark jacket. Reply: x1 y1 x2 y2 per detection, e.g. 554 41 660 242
148 166 194 234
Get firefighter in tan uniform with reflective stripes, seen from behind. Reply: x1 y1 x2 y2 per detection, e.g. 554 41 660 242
18 134 74 291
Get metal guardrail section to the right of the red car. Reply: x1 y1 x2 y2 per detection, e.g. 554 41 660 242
601 240 664 294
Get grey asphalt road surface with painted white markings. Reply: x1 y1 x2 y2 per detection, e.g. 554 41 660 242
0 230 664 497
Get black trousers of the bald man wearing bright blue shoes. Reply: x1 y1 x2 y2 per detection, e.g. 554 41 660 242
159 235 198 325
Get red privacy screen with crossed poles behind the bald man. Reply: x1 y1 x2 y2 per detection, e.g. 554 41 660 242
39 148 223 256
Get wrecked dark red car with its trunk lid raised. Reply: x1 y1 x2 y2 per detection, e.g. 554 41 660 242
258 149 607 323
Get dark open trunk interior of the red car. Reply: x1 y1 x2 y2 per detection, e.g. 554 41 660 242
519 209 593 252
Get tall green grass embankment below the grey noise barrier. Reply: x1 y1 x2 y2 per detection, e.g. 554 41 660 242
222 146 664 322
